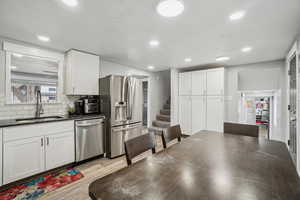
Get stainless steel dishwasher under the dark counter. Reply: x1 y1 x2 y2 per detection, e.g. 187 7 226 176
75 118 105 162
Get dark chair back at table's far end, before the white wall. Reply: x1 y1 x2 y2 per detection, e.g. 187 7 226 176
224 122 259 137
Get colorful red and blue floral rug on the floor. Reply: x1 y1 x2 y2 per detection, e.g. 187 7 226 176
0 169 83 200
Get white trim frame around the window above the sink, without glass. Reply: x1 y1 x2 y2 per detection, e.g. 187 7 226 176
3 42 64 105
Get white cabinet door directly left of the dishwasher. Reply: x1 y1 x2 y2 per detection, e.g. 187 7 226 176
45 132 75 170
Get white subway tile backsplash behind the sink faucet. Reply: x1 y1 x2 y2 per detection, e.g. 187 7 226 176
0 95 78 120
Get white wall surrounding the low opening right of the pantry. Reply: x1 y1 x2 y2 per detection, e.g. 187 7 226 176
224 60 287 142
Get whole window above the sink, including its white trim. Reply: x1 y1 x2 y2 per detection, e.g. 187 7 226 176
4 43 64 104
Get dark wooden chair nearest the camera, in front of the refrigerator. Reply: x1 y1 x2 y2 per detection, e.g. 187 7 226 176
125 133 155 165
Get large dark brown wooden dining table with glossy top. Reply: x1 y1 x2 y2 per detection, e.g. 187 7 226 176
89 131 300 200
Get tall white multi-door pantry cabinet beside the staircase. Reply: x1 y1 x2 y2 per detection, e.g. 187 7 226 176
178 68 224 135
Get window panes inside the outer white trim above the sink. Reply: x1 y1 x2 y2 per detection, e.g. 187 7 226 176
6 52 59 104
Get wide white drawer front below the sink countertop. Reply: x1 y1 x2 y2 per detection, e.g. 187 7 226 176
3 120 74 142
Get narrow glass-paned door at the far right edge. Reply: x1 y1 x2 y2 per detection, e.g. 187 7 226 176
289 53 297 163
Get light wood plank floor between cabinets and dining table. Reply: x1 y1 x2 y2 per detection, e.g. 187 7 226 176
39 136 166 200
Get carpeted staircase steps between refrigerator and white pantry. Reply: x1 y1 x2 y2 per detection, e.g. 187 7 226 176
150 99 171 135
